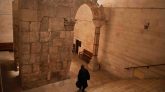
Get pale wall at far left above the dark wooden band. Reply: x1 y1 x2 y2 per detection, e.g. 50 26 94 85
0 0 13 43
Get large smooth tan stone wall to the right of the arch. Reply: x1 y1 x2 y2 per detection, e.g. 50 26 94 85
98 0 165 78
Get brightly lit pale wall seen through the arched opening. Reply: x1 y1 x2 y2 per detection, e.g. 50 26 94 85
74 4 95 55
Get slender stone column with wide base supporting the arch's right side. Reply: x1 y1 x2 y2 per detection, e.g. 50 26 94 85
88 19 102 71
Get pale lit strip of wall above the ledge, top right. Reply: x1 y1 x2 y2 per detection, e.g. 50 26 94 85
98 0 165 8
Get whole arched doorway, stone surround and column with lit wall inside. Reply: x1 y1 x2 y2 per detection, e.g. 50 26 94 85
71 0 104 76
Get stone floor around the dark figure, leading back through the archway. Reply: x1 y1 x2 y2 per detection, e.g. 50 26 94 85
23 55 118 92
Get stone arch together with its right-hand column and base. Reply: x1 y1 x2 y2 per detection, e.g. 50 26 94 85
73 0 105 71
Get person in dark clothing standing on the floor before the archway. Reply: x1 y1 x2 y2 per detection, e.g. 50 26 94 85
76 65 90 92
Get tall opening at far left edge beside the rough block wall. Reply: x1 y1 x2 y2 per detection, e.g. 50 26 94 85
0 0 20 92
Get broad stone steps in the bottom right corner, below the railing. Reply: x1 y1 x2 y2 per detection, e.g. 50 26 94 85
88 79 165 92
